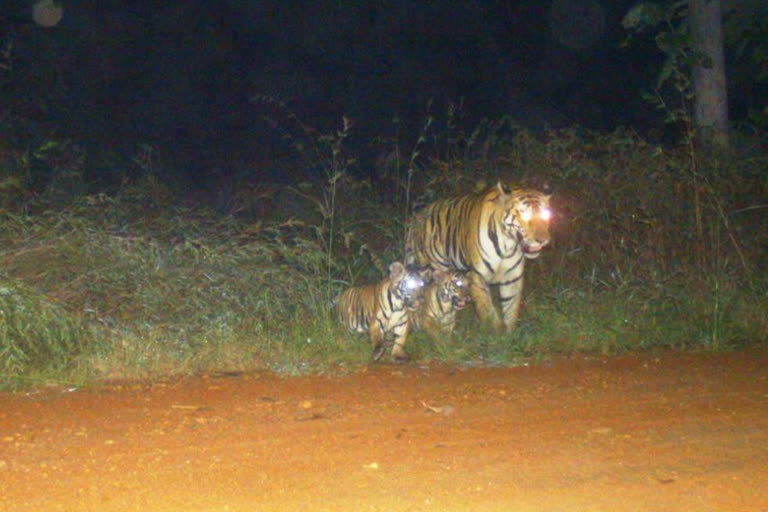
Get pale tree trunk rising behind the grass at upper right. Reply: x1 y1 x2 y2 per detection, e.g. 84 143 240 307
688 0 728 147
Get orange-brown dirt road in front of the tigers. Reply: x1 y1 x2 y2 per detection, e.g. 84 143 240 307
0 349 768 512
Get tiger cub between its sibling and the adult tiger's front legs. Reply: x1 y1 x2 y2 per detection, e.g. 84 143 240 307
411 270 472 342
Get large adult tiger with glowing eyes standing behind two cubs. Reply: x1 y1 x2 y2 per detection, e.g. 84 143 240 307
406 182 551 331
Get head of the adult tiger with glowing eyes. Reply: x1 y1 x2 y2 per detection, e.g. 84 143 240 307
497 182 552 259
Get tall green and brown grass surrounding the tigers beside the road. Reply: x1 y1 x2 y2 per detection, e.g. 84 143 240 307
0 122 768 387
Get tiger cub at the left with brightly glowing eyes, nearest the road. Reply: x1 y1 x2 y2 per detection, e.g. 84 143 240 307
335 261 424 362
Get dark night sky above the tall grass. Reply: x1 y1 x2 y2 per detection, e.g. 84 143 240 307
2 0 764 182
